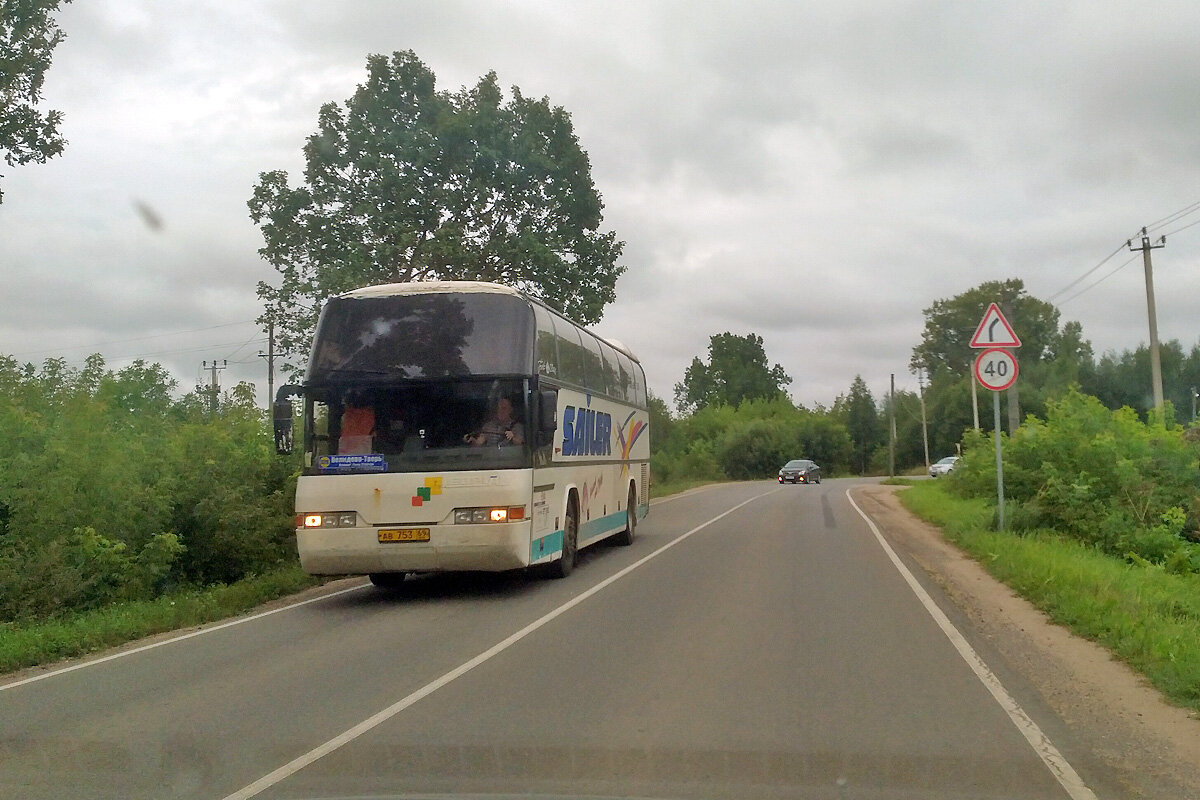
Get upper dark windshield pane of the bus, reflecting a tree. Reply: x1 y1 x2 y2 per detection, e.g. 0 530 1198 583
306 293 534 385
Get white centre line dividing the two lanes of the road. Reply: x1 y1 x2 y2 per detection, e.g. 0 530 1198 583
224 488 779 800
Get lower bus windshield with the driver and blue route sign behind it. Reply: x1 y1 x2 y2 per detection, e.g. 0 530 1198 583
305 378 532 474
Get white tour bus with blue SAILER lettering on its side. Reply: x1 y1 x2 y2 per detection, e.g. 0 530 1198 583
274 282 649 585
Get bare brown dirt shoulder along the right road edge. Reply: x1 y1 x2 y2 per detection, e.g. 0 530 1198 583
854 486 1200 798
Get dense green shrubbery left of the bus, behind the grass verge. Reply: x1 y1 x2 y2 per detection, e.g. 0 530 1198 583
0 355 294 621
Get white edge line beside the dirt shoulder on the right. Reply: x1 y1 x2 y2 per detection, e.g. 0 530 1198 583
846 489 1097 800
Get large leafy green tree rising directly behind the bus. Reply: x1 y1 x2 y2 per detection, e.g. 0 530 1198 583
248 50 624 359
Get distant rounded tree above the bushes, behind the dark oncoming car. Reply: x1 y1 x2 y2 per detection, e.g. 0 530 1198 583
674 331 792 413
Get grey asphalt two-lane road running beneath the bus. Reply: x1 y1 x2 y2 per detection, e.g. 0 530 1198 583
0 481 1121 800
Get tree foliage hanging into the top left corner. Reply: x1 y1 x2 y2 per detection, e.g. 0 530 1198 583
0 0 71 203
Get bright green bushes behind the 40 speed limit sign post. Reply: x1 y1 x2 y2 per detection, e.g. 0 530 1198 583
949 389 1200 572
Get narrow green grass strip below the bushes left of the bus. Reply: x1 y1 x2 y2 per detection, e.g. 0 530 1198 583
0 565 319 673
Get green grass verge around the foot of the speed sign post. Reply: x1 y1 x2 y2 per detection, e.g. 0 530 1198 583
900 481 1200 710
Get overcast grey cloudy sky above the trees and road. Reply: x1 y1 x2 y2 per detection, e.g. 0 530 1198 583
0 0 1200 407
